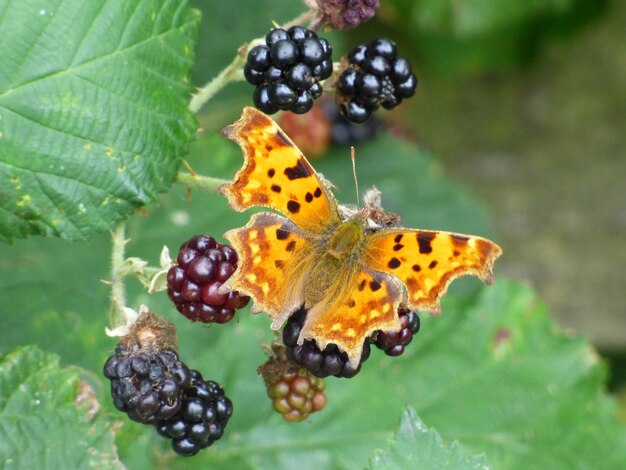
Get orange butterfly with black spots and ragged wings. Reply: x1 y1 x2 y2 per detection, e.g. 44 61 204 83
220 107 502 368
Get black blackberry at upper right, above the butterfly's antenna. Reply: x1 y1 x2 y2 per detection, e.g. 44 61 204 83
337 39 417 123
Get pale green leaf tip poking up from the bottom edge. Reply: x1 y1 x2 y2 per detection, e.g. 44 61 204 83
370 408 492 470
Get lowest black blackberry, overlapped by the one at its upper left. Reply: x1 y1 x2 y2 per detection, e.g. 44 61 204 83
156 370 233 456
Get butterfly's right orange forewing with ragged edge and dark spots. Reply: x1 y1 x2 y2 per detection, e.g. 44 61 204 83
365 228 502 313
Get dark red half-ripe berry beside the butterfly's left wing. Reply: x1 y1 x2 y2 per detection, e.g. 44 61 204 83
167 235 250 323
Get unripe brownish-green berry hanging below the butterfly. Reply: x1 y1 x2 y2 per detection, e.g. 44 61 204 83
259 359 327 422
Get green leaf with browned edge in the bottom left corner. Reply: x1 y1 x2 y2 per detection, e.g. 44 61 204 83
0 347 123 470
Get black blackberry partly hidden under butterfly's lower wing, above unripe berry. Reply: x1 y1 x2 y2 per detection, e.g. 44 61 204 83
283 308 371 378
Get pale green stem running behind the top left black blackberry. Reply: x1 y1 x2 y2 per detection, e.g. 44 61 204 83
189 10 316 113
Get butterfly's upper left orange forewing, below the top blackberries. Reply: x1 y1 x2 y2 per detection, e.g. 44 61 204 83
221 107 340 233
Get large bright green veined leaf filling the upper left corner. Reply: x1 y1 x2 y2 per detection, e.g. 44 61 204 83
0 0 199 240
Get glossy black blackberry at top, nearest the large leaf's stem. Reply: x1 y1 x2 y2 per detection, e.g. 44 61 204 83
243 26 333 114
